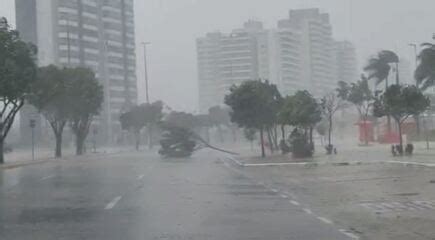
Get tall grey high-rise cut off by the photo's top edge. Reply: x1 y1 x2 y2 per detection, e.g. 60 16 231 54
16 0 137 142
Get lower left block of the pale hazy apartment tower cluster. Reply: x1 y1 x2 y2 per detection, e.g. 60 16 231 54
197 21 268 112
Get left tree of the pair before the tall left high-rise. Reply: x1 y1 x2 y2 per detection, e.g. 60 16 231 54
29 65 71 158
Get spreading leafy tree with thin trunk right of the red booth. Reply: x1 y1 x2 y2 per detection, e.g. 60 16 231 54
373 85 430 152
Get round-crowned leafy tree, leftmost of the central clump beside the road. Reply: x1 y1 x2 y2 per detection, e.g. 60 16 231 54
225 81 281 157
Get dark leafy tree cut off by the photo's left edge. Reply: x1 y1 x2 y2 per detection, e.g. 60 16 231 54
0 19 37 164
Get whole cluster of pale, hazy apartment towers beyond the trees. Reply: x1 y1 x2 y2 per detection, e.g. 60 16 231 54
197 9 357 112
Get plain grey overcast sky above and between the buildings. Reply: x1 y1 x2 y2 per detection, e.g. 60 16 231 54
0 0 435 111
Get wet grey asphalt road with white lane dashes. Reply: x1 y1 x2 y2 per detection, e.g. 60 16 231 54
0 152 352 240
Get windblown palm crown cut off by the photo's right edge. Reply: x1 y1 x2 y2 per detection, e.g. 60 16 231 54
414 43 435 91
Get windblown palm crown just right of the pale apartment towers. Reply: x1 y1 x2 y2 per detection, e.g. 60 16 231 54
364 50 399 88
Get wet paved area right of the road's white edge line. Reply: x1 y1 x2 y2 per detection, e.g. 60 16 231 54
233 155 435 240
